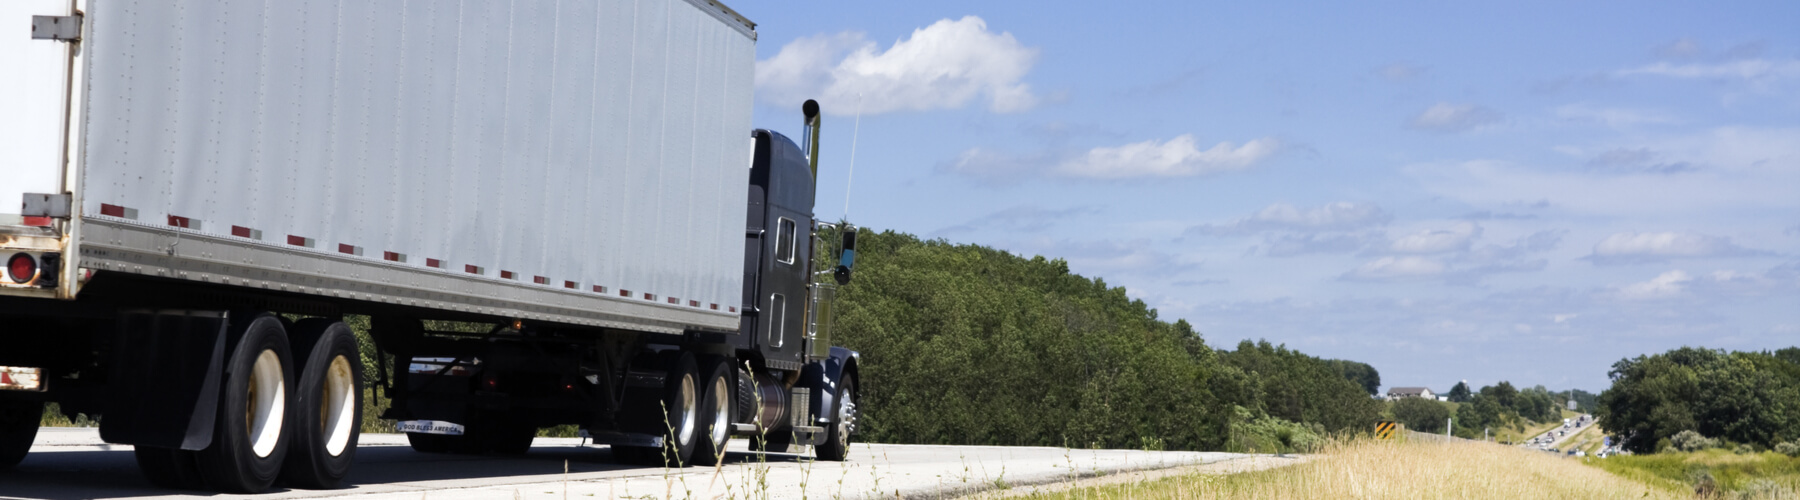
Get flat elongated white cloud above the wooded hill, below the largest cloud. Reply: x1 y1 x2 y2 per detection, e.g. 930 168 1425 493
1057 135 1280 180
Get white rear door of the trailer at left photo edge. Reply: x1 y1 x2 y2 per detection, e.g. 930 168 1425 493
0 0 70 227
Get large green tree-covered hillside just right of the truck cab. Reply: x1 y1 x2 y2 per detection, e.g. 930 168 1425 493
828 230 1382 451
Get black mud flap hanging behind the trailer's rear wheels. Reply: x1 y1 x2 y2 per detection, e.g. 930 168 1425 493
101 311 230 450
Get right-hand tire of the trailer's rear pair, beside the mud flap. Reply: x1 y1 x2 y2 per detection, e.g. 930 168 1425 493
281 318 364 489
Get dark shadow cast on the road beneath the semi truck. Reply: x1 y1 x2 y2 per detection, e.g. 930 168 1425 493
0 446 812 500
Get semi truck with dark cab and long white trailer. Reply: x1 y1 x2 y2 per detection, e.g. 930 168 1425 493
0 0 860 493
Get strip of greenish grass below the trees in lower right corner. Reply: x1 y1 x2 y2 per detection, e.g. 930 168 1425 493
1580 450 1800 498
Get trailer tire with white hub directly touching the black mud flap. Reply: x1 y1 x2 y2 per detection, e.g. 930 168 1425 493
200 315 293 493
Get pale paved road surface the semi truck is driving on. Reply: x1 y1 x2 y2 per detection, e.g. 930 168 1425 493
0 428 1253 500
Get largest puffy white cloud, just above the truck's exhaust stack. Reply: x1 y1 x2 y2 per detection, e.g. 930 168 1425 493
756 16 1039 115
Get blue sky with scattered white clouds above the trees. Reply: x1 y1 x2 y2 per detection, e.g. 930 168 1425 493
731 2 1800 390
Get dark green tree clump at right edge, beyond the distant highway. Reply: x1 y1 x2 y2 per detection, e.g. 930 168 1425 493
1595 347 1800 453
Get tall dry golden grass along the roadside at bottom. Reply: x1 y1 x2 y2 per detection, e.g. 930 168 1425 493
1037 433 1690 498
